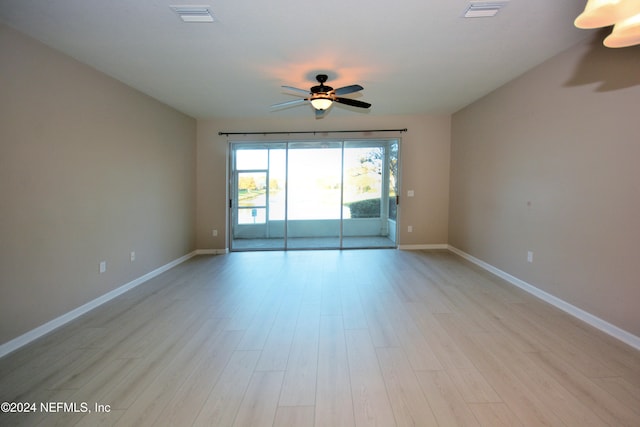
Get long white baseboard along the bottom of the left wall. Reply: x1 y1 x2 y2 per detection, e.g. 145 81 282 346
0 251 197 357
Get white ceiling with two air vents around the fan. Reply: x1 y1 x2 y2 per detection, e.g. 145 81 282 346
0 0 591 118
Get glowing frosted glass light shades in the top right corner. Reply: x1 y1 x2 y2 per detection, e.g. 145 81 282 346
574 0 640 47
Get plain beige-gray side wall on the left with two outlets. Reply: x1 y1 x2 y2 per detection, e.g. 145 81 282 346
0 25 196 344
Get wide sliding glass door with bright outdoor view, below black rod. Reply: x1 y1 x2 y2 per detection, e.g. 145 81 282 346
230 140 398 250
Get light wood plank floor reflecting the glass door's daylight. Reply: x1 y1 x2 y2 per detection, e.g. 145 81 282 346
0 250 640 427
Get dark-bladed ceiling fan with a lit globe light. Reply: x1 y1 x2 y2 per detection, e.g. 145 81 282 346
271 74 371 119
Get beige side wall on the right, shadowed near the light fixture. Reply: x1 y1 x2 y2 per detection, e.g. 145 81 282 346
449 35 640 336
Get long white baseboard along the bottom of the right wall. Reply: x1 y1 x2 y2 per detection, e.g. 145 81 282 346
448 245 640 350
